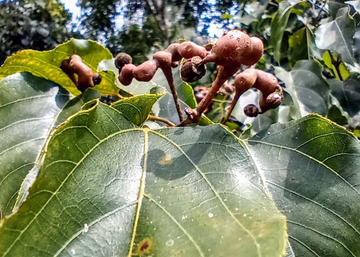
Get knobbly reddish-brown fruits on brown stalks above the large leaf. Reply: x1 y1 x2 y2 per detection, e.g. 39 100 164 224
61 30 283 126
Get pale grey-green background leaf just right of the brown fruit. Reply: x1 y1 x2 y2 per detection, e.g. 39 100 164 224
275 60 330 119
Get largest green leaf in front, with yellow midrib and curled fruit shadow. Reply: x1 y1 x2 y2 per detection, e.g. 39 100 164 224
0 103 286 257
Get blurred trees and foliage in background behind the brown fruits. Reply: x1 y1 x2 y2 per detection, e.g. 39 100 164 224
0 0 360 136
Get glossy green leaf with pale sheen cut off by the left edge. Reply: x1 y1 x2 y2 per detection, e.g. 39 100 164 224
0 73 69 215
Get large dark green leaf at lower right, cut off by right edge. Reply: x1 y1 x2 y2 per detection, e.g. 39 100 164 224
249 115 360 257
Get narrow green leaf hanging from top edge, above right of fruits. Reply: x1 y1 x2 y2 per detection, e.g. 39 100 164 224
270 1 292 64
